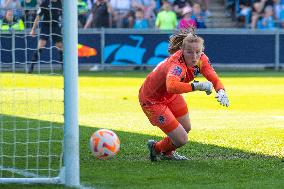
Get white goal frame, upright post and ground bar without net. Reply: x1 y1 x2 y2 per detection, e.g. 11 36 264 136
0 0 80 187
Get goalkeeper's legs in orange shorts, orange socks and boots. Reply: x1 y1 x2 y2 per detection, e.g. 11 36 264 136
142 95 191 161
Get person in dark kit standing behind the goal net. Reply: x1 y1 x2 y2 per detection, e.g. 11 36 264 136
28 0 63 73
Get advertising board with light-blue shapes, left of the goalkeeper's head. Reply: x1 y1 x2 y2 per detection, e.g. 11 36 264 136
104 34 169 65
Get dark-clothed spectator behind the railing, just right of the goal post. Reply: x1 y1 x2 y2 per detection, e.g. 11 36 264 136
84 0 111 29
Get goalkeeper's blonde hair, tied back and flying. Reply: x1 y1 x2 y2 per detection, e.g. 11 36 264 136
168 27 204 54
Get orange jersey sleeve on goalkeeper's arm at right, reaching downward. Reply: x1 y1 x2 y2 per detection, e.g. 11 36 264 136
200 55 225 91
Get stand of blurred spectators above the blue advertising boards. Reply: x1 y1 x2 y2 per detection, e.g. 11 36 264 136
0 0 284 29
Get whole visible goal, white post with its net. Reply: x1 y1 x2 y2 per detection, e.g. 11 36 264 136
0 0 80 187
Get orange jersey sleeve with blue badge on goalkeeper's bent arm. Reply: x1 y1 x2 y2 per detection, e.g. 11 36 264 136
166 65 192 94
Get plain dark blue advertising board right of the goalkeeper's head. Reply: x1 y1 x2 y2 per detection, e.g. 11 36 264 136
201 34 275 64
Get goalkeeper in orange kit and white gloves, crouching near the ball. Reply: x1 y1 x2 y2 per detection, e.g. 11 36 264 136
139 29 229 161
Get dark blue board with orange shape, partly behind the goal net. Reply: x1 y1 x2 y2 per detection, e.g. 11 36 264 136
0 34 101 64
